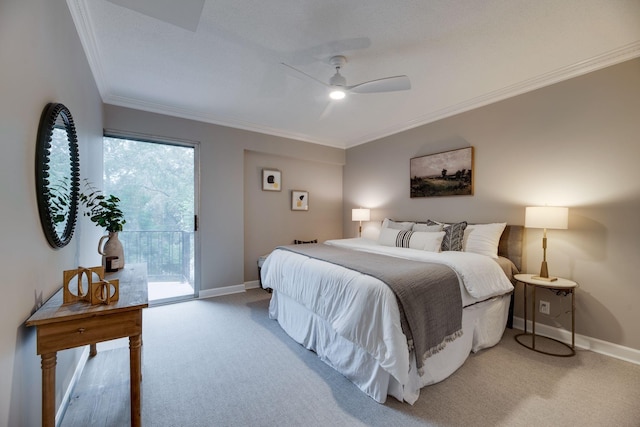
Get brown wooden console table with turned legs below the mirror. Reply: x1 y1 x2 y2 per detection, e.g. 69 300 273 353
26 264 149 427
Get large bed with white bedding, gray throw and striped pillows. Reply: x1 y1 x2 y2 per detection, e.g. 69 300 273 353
261 219 523 404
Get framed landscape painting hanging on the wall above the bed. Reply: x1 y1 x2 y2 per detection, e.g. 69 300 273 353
409 147 473 197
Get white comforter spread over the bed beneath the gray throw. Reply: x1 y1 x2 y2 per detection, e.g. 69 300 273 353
262 239 513 402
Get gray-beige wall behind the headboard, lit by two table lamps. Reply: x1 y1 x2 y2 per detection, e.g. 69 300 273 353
343 60 640 349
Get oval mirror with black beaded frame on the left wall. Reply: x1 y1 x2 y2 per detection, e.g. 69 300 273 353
36 103 80 248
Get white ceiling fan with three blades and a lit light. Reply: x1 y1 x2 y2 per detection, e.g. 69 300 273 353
281 55 411 99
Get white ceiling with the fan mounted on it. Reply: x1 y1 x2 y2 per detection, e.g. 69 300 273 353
67 0 640 148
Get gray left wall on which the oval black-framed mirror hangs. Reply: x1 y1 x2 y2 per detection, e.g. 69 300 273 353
0 0 102 426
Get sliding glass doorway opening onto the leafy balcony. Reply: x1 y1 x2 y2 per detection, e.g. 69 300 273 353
103 135 199 305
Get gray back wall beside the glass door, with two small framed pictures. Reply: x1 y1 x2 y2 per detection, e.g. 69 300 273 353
104 105 345 291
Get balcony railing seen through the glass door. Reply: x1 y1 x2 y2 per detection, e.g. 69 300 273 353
118 230 194 285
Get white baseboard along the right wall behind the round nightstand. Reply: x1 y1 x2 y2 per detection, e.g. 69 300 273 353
513 317 640 365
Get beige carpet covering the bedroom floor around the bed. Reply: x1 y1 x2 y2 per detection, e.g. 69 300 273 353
62 289 640 427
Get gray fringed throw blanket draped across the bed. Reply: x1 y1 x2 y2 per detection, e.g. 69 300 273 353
278 244 462 373
